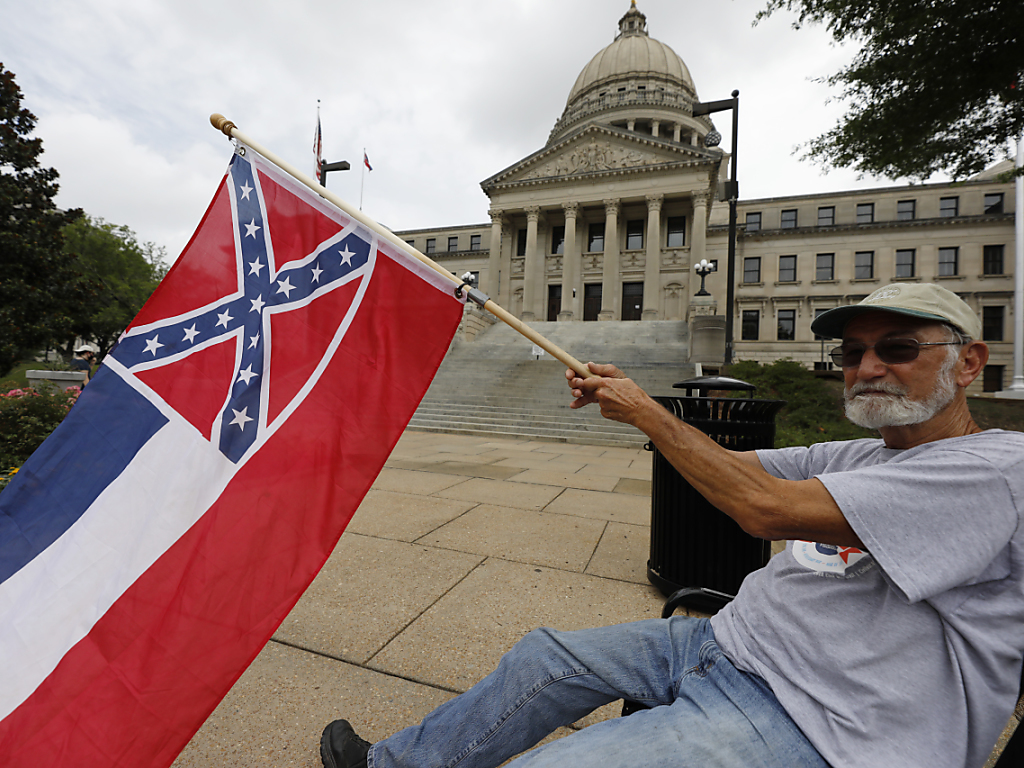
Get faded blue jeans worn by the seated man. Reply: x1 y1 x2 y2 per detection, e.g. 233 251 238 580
368 616 827 768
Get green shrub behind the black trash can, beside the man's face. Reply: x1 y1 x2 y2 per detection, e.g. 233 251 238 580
728 359 879 447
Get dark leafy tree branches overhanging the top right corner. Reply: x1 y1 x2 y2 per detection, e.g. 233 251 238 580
755 0 1024 179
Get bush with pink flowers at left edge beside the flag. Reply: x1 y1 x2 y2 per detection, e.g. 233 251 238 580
0 387 81 475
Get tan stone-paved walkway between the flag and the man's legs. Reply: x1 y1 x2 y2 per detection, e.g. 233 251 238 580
174 430 663 768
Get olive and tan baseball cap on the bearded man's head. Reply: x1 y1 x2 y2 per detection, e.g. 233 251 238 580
811 283 981 339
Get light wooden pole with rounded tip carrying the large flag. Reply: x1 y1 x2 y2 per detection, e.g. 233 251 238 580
210 114 595 379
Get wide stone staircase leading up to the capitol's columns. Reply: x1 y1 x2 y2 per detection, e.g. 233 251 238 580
409 321 695 446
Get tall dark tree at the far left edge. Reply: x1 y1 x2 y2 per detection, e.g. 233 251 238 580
0 63 86 376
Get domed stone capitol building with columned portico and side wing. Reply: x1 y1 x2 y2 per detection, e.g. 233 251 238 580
396 1 1015 391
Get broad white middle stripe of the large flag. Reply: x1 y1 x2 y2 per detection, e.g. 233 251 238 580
0 409 238 719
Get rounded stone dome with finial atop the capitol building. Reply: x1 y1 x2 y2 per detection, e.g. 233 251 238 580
548 0 712 144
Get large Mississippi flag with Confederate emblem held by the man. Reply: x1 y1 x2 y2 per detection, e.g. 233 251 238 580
0 145 463 768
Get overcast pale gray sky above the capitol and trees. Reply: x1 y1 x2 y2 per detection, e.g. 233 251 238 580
0 0 946 260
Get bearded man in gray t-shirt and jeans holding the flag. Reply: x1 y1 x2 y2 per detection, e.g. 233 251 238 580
321 284 1024 768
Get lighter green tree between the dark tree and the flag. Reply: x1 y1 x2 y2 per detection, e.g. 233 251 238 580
63 215 167 358
